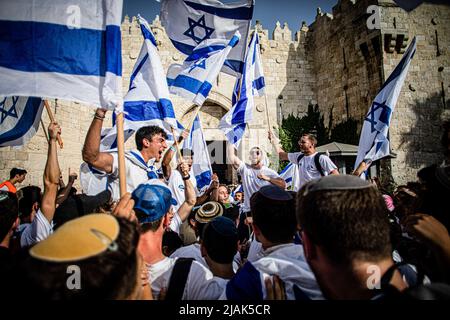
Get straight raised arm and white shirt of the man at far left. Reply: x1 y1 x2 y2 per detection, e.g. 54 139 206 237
20 122 61 247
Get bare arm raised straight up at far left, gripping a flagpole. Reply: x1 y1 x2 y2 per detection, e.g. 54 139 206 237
41 122 61 222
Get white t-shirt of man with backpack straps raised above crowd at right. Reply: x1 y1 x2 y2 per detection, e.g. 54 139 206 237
288 152 337 190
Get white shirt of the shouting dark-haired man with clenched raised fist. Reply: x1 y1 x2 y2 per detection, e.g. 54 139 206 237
108 150 158 201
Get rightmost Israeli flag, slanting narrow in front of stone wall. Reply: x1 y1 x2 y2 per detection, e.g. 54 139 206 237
355 37 416 172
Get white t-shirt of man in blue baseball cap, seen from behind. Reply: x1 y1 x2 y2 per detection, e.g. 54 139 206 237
148 257 224 300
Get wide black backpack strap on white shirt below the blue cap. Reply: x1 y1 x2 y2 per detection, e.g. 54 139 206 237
166 258 194 301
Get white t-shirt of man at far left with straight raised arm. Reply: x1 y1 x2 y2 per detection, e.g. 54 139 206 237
20 209 53 247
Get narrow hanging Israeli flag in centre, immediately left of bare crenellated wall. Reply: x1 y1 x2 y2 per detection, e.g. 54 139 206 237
219 31 265 149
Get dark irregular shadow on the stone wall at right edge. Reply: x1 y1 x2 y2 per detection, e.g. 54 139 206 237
399 94 450 169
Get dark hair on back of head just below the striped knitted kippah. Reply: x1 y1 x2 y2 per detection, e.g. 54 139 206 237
202 217 238 264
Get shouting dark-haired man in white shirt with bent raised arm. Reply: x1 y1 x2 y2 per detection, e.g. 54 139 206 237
82 109 167 200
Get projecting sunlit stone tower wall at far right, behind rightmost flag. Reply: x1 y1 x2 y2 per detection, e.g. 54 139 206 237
380 0 450 183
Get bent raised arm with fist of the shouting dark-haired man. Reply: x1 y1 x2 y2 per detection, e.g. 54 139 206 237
82 109 113 173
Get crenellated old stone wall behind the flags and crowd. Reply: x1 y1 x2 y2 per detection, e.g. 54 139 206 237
0 0 450 186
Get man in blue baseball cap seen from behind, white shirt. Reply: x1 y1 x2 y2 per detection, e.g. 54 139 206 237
132 185 223 300
